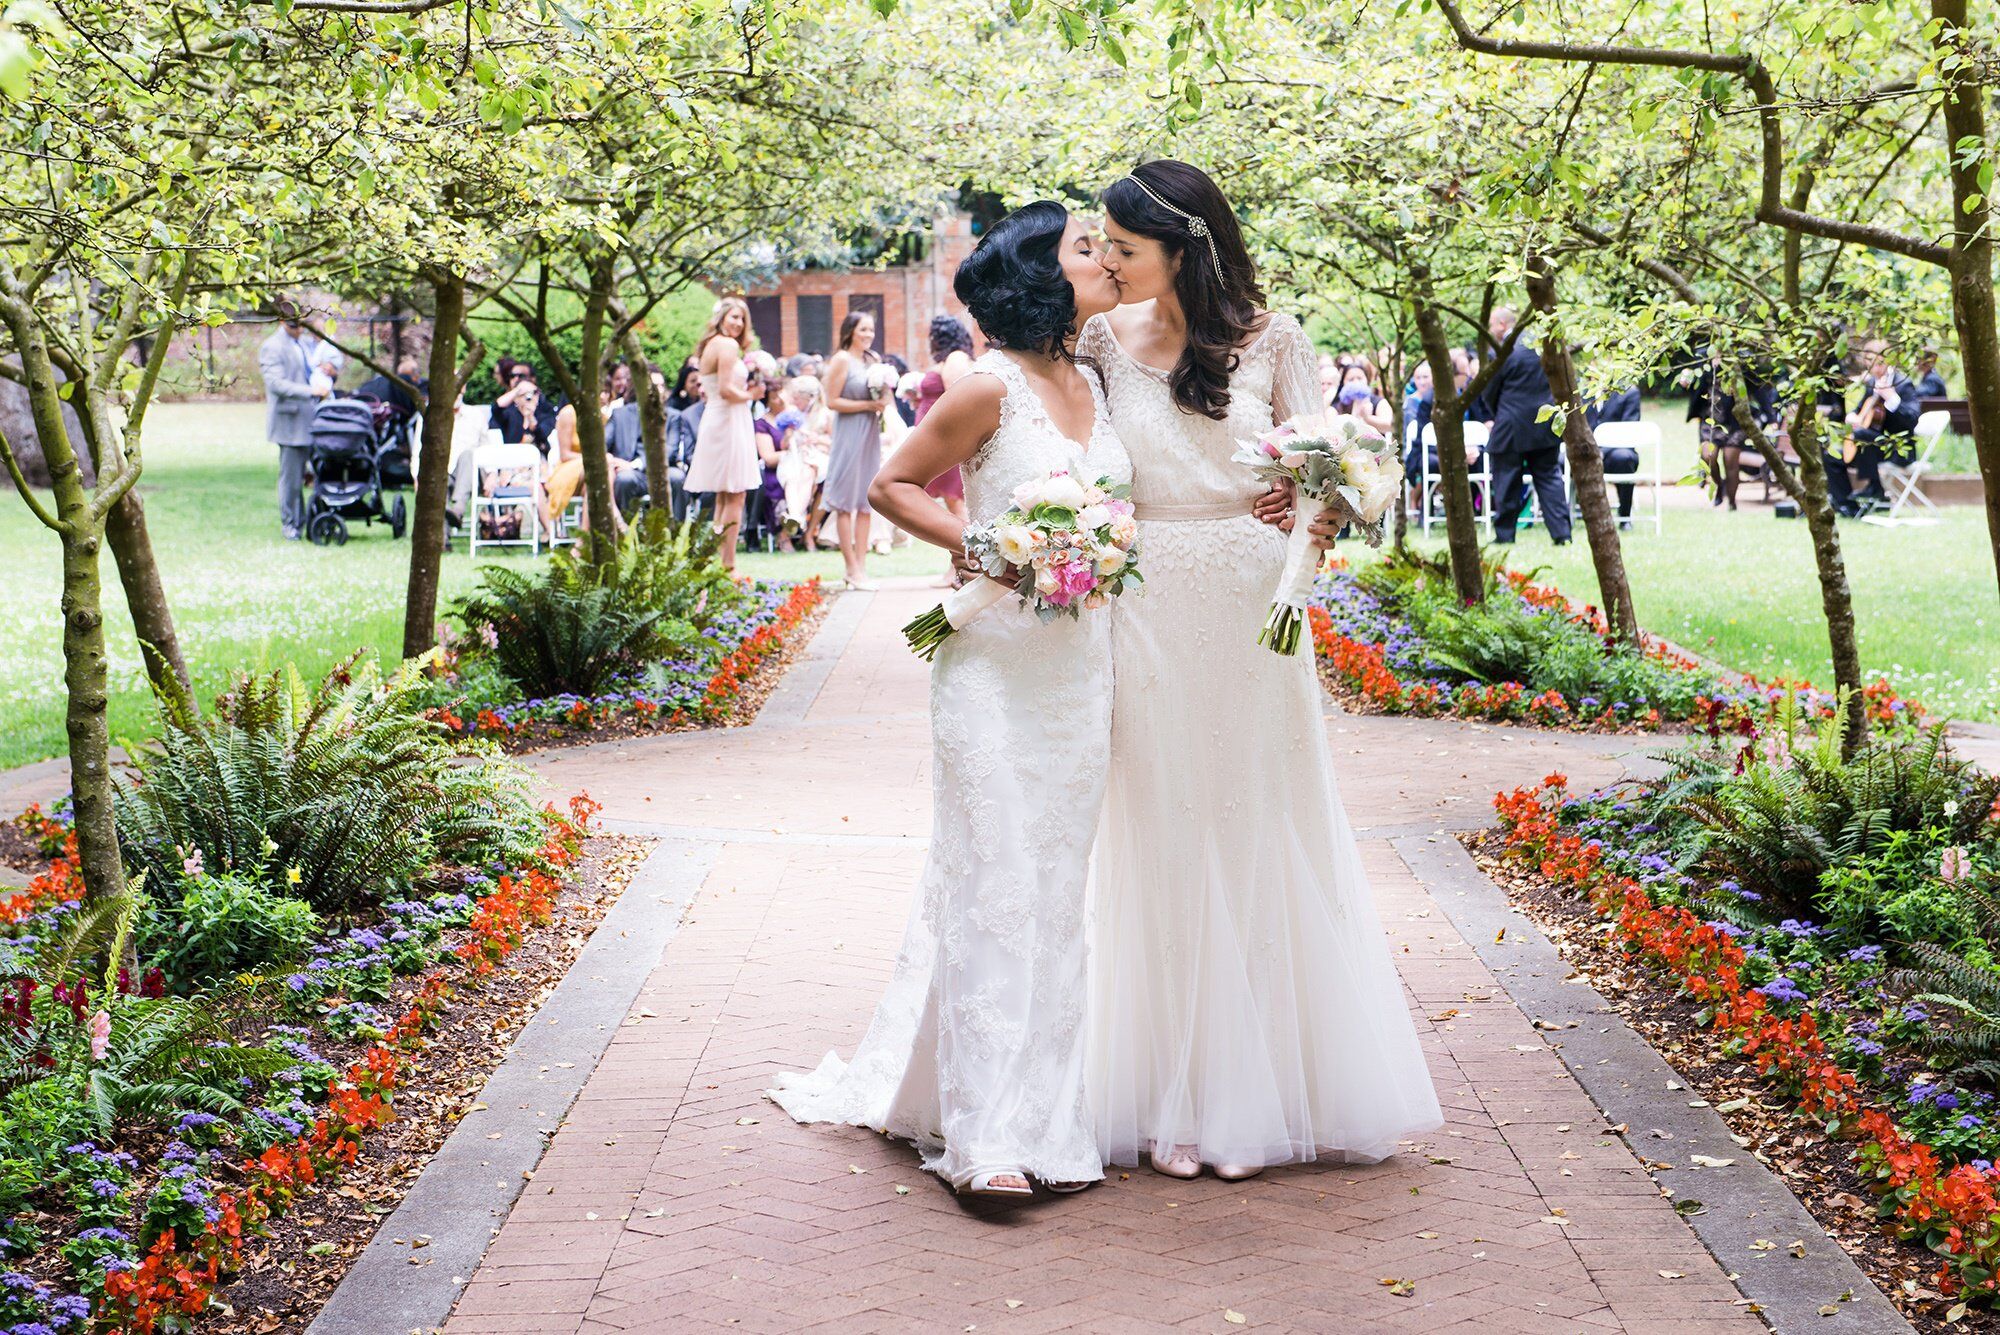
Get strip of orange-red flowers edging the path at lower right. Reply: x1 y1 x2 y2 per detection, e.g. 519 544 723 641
1494 773 2000 1301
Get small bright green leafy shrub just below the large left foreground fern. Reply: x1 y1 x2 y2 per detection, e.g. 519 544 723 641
138 871 320 991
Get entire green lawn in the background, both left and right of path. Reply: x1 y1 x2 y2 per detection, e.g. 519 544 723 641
0 404 2000 767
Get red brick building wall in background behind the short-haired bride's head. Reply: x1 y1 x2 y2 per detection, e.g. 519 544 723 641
742 214 978 368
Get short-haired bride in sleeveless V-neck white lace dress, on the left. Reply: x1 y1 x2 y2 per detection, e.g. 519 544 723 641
772 200 1132 1195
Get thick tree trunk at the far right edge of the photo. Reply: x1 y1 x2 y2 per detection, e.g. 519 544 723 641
1930 0 2000 595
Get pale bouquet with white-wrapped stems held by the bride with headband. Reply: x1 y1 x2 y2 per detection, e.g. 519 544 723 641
1236 414 1402 654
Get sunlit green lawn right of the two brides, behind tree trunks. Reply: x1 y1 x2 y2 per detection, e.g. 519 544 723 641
1376 503 2000 721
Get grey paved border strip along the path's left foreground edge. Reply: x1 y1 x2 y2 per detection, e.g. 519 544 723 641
308 839 718 1335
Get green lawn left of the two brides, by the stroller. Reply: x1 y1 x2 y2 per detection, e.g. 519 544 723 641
0 404 944 767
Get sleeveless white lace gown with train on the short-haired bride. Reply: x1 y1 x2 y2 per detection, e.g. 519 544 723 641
772 352 1144 1185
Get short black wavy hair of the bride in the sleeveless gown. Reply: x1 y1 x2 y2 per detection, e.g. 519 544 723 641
952 200 1076 356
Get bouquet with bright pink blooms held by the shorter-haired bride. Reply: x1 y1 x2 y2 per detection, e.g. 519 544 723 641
902 472 1140 660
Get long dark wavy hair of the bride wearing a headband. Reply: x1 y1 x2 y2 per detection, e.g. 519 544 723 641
1104 158 1264 422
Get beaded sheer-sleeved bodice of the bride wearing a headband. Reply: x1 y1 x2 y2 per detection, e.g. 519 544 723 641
1078 314 1324 512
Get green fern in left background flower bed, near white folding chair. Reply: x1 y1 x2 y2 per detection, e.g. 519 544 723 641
456 514 738 697
